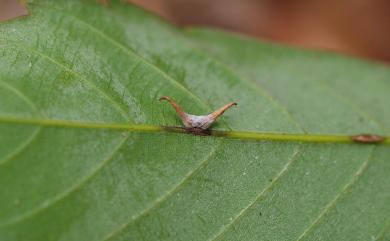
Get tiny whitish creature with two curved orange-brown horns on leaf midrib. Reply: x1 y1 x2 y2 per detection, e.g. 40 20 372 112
159 96 237 133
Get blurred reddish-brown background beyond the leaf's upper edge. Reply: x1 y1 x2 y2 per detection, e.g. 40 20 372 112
0 0 390 63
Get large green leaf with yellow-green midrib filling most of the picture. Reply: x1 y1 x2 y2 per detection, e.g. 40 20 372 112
0 0 390 241
